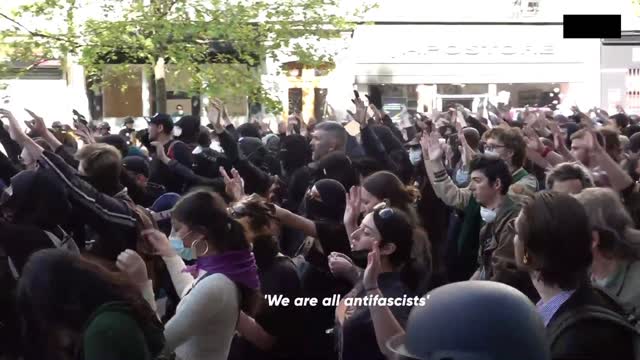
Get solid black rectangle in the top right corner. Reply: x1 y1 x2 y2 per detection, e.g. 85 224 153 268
562 14 622 39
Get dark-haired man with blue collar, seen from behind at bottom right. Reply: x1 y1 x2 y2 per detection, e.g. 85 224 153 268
509 191 637 360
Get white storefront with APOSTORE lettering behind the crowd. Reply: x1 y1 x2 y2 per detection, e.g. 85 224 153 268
352 24 600 114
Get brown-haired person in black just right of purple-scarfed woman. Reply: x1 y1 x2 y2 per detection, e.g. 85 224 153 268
228 194 303 360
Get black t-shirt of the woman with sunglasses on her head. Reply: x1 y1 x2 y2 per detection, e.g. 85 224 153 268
336 272 415 360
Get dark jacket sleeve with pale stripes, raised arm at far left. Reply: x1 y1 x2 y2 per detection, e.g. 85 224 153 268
38 151 138 261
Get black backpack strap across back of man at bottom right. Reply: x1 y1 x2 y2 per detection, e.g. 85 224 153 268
549 305 640 360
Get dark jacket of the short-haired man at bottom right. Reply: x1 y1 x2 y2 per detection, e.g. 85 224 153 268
547 285 633 360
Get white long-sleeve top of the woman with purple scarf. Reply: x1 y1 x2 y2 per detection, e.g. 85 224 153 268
163 255 240 360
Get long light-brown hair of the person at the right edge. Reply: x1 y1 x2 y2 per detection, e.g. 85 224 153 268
575 188 640 260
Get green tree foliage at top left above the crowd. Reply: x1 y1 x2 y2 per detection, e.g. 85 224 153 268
0 0 372 112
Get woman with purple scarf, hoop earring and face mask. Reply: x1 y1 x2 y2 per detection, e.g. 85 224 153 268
118 191 261 360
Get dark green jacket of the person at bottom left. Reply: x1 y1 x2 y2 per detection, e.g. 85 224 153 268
81 302 164 360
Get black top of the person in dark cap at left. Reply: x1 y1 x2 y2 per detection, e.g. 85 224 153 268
149 140 193 194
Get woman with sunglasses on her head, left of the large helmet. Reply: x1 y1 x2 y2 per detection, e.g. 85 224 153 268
335 203 424 360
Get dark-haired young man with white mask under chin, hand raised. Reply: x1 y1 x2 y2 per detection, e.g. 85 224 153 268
425 133 538 301
